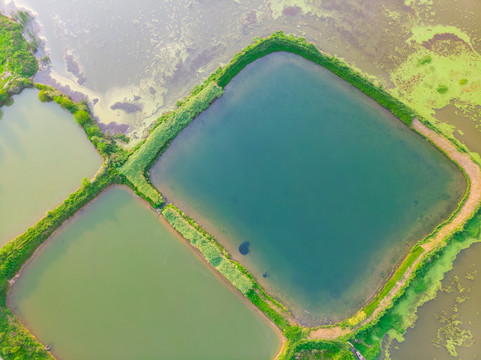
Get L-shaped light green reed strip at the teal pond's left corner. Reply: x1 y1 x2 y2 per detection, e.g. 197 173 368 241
120 82 222 207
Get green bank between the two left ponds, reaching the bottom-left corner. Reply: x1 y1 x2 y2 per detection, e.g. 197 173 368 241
0 168 118 360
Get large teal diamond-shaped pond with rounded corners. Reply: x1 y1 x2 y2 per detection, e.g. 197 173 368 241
151 54 466 325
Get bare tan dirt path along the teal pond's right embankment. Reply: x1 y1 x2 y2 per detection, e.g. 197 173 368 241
308 119 481 340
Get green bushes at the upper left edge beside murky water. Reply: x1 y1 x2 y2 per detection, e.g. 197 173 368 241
0 15 38 104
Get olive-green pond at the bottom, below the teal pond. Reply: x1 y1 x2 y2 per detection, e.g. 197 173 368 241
8 186 280 360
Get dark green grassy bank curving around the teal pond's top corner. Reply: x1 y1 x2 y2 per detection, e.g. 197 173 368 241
217 32 416 125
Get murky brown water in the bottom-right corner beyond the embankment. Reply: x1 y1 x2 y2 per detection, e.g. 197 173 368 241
391 243 481 360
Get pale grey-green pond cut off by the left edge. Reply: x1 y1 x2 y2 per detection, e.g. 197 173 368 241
0 89 102 246
